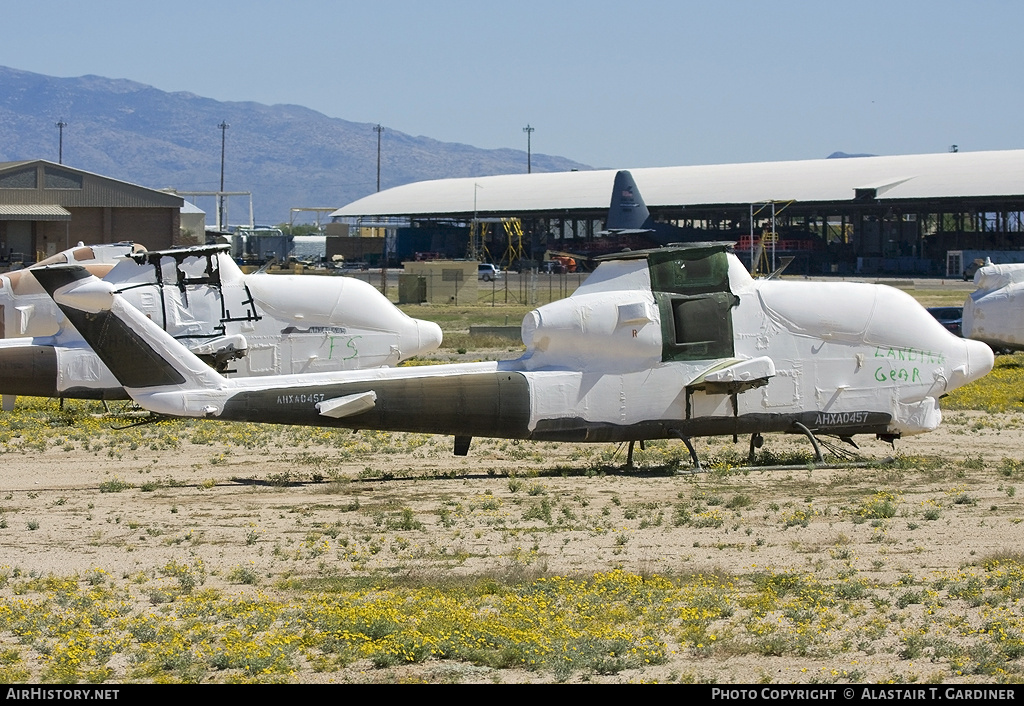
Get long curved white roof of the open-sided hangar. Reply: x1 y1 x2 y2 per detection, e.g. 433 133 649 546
332 150 1024 217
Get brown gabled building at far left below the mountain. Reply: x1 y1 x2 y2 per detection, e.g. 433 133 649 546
0 160 184 265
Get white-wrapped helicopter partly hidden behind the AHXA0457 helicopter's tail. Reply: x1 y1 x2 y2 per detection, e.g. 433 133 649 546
0 244 441 406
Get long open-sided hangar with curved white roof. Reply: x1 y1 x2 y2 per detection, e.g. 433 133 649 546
332 150 1024 275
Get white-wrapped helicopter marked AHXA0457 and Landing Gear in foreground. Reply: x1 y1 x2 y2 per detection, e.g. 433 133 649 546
36 243 993 465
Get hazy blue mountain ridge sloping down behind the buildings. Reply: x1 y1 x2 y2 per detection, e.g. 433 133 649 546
0 67 590 223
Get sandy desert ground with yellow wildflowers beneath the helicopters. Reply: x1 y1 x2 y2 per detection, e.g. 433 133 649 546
0 391 1024 683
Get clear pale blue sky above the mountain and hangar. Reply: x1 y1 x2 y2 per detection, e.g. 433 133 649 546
0 0 1024 167
